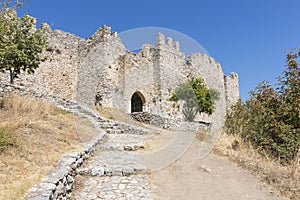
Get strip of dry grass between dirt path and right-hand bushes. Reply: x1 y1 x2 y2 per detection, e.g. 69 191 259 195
214 134 300 200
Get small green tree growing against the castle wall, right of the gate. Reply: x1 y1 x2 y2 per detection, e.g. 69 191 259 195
170 77 220 121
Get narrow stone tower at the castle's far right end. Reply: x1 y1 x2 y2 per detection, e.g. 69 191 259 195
224 72 240 111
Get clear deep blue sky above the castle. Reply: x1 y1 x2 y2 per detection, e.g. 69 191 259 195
18 0 300 100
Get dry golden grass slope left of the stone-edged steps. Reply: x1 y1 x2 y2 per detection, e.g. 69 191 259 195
0 97 81 200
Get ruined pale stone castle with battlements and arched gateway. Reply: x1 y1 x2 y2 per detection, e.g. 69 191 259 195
0 24 239 125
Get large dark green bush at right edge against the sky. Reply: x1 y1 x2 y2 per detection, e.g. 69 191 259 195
225 49 300 161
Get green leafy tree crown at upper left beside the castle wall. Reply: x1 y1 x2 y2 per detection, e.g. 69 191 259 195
0 1 47 83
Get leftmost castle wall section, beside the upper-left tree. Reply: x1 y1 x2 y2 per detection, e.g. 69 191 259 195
1 24 84 99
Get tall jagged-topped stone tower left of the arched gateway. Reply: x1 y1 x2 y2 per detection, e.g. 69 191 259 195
76 26 126 107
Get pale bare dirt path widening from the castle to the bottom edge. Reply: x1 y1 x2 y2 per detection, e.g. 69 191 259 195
82 110 283 200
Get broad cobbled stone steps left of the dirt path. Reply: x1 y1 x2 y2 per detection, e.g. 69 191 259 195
71 126 152 200
